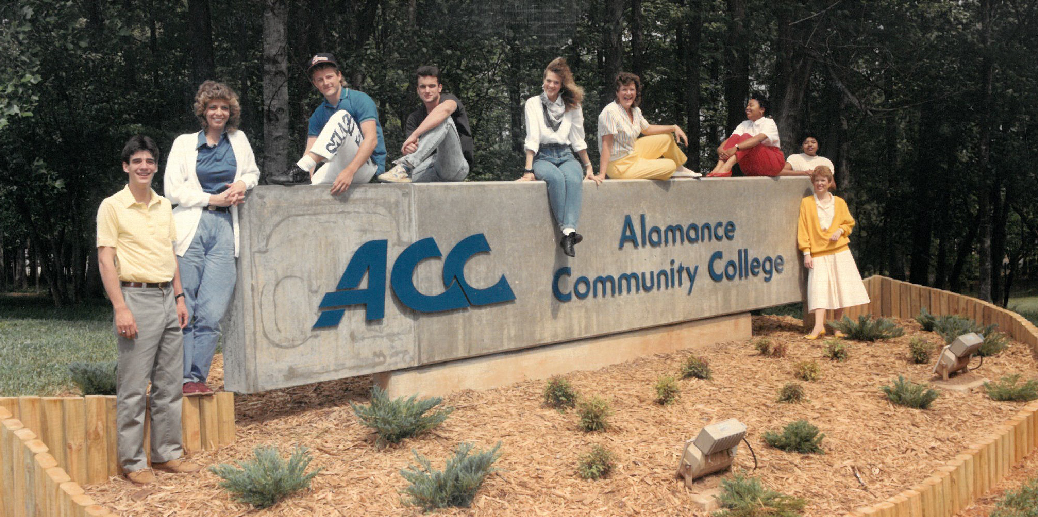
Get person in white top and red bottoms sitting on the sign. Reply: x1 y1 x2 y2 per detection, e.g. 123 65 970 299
707 96 786 178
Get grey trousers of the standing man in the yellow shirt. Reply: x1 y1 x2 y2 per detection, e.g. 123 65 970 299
115 288 184 472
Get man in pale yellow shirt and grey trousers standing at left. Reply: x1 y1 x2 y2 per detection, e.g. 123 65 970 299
98 135 201 485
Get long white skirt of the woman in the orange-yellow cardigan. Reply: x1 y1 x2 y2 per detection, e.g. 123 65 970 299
808 249 869 310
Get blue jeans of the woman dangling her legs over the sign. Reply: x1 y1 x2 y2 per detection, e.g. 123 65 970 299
534 144 583 230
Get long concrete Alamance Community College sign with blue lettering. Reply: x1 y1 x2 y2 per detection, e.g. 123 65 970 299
224 178 810 392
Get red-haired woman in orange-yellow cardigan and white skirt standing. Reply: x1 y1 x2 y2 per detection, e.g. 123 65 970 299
796 166 869 339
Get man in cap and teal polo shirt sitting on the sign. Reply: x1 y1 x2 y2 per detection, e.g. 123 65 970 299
268 54 386 194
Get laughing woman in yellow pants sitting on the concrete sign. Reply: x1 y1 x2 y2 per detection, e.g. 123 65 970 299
598 72 700 180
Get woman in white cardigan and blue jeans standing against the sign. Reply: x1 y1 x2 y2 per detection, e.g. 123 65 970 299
164 81 260 394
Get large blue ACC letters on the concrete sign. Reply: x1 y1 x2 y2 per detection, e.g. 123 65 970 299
313 234 516 329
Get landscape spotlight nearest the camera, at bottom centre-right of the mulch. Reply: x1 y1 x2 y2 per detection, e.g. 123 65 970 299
678 418 746 488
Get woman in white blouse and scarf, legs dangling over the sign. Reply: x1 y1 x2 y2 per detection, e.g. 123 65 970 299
519 57 603 256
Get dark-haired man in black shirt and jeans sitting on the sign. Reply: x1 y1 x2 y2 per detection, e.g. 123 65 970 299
379 66 472 183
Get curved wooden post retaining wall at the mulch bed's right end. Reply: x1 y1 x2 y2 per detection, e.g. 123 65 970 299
828 276 1038 517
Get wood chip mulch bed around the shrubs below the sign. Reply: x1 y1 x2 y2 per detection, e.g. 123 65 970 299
87 317 1036 517
